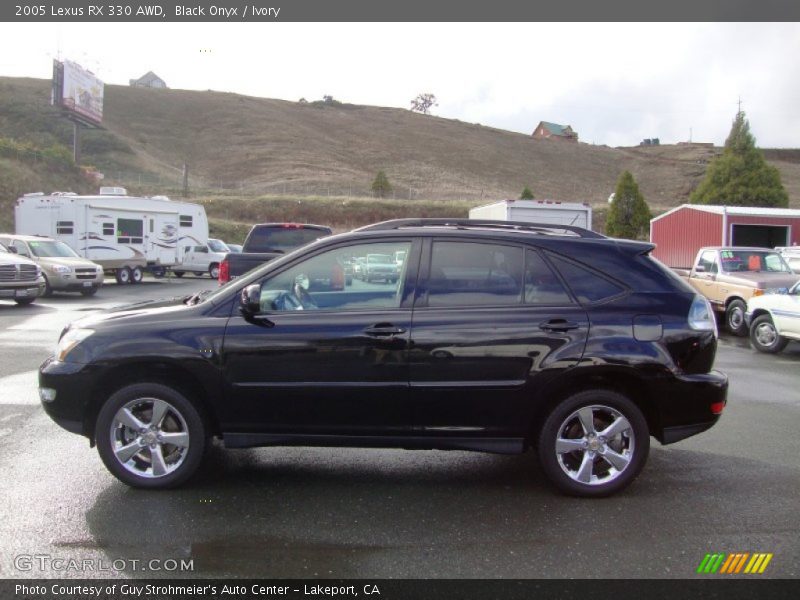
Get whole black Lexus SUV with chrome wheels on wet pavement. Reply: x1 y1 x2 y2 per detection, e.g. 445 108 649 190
39 219 728 496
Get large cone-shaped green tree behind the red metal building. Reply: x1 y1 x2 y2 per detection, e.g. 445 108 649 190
689 111 789 208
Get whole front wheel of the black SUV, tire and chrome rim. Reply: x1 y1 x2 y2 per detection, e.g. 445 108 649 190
95 383 207 489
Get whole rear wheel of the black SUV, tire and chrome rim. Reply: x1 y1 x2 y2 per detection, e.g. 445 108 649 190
538 390 650 498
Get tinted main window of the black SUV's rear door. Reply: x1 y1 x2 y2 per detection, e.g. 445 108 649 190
428 242 522 307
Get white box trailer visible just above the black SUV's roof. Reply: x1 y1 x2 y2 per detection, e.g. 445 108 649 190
469 200 592 229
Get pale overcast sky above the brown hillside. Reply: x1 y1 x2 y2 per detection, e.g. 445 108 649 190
0 23 800 148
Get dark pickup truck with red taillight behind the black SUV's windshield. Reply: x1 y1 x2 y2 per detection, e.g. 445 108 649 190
219 223 332 283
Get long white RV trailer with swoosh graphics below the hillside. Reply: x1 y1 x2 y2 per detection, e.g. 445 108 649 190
14 188 208 283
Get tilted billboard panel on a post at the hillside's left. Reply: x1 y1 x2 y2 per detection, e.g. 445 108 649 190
53 60 103 124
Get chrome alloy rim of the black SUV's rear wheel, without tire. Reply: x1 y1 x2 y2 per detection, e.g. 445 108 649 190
555 405 636 485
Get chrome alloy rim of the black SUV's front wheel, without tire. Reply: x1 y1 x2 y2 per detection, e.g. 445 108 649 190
110 398 189 479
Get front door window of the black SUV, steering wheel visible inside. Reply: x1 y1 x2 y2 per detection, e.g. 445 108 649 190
261 240 411 312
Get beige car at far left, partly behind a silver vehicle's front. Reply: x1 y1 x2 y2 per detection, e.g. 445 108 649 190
0 234 103 296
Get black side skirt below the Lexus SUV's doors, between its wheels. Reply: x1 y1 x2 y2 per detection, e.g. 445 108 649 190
222 433 525 454
